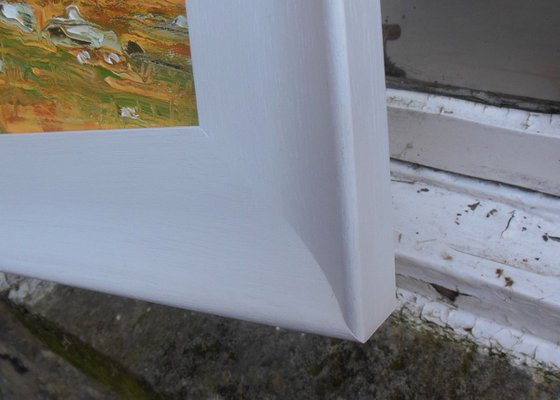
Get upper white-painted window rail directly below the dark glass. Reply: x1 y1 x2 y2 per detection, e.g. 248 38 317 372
387 89 560 196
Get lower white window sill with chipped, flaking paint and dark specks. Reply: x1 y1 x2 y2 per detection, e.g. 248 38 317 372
391 161 560 369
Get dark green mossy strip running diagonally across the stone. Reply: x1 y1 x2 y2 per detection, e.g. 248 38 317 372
0 299 165 400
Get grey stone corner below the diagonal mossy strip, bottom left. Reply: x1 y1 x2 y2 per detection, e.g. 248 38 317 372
0 303 116 400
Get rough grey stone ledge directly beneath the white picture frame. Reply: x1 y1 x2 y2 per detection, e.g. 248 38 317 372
2 286 560 399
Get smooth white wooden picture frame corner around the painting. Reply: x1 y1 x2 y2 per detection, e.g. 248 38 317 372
0 0 396 341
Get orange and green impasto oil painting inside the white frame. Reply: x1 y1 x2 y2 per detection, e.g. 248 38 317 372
0 0 198 133
